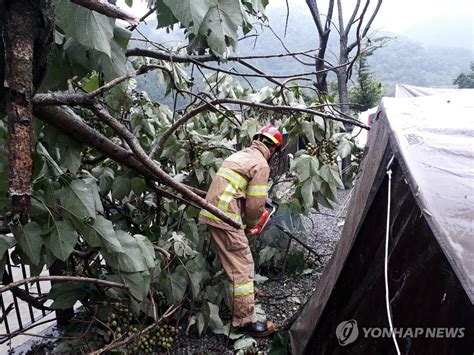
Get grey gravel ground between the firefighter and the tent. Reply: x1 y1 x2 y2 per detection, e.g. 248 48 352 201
171 190 351 354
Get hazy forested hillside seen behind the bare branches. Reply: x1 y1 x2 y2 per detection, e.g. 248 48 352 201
135 4 474 96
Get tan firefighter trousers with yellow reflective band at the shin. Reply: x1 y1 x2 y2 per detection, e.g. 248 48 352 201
208 225 257 327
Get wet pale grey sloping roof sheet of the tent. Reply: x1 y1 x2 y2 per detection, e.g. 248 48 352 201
381 90 474 303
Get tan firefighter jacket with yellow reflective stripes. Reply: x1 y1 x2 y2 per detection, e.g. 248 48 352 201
199 141 271 230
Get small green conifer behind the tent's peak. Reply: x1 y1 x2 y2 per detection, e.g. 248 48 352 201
349 53 383 112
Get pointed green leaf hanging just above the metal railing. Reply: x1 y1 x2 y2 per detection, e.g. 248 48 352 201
11 222 43 265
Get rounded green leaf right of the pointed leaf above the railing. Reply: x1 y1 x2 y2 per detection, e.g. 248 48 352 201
46 221 79 261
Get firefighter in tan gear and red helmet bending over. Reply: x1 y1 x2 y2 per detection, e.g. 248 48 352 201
199 125 283 337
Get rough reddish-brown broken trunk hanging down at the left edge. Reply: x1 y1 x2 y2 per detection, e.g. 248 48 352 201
4 0 36 222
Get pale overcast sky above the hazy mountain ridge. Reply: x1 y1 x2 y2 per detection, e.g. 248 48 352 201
117 0 474 33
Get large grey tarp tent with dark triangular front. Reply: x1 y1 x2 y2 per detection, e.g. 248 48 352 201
290 90 474 354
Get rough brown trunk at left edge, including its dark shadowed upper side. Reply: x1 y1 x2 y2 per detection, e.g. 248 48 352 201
2 0 52 222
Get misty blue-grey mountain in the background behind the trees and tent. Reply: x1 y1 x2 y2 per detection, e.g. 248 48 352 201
134 6 474 95
